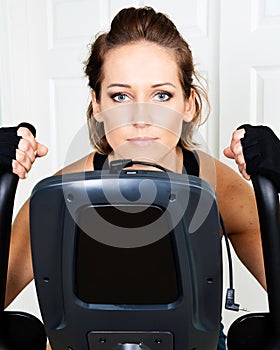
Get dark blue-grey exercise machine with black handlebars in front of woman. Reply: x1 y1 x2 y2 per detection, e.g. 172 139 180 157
0 143 280 350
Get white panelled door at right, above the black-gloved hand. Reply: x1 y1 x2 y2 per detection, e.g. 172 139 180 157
220 0 280 160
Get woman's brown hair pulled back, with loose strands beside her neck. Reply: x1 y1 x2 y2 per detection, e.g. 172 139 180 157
85 7 209 154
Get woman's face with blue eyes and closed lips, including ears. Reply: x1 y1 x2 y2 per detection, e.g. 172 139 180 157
92 41 194 166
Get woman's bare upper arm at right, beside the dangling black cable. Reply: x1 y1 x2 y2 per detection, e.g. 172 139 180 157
201 159 266 288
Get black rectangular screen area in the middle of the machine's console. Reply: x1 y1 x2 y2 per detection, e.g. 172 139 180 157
75 206 179 305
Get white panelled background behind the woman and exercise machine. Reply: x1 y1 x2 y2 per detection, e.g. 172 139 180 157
0 0 280 334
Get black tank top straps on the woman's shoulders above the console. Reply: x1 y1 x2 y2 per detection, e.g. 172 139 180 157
93 148 199 176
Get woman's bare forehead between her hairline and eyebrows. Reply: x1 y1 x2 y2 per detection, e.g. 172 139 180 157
103 41 178 80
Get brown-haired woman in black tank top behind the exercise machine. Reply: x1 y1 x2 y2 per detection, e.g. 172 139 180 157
3 8 265 350
